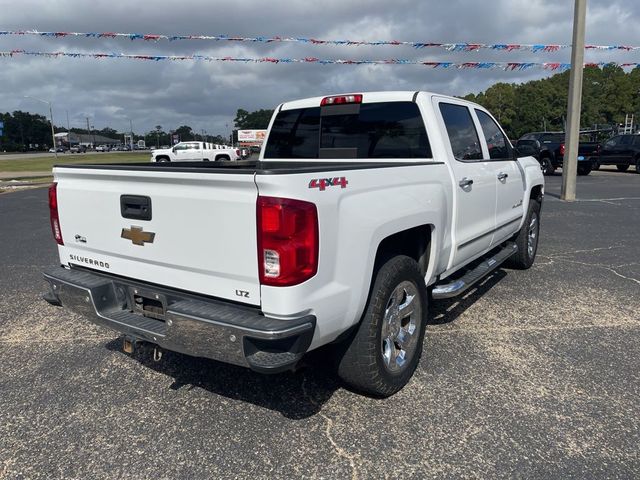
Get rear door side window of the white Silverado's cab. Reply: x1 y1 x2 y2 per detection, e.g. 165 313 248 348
440 103 482 161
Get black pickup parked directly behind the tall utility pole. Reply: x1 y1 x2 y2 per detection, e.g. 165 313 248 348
516 132 600 175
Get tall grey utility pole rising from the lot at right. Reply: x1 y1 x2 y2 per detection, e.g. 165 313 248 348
560 0 587 202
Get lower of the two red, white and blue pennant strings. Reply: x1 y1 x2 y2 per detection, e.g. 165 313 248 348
0 50 640 72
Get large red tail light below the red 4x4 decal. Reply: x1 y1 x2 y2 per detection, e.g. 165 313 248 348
257 197 319 287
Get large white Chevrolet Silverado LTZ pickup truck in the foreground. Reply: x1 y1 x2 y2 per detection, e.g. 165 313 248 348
44 92 544 396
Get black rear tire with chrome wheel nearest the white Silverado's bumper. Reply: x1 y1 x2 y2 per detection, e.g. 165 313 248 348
338 256 427 397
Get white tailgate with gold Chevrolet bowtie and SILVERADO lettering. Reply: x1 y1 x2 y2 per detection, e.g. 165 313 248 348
54 167 260 305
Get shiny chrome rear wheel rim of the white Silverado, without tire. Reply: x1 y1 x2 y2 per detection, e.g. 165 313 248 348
382 281 422 372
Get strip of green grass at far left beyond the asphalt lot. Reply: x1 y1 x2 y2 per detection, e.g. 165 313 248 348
0 151 151 172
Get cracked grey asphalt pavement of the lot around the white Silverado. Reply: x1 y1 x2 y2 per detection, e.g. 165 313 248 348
0 170 640 479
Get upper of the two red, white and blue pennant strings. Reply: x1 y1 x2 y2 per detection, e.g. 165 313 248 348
0 30 640 53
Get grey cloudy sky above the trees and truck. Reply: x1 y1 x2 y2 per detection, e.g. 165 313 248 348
0 0 640 134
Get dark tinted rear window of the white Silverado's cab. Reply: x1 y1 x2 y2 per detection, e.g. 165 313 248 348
264 102 432 159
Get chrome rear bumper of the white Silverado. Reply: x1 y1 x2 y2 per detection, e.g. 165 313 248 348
43 267 316 373
